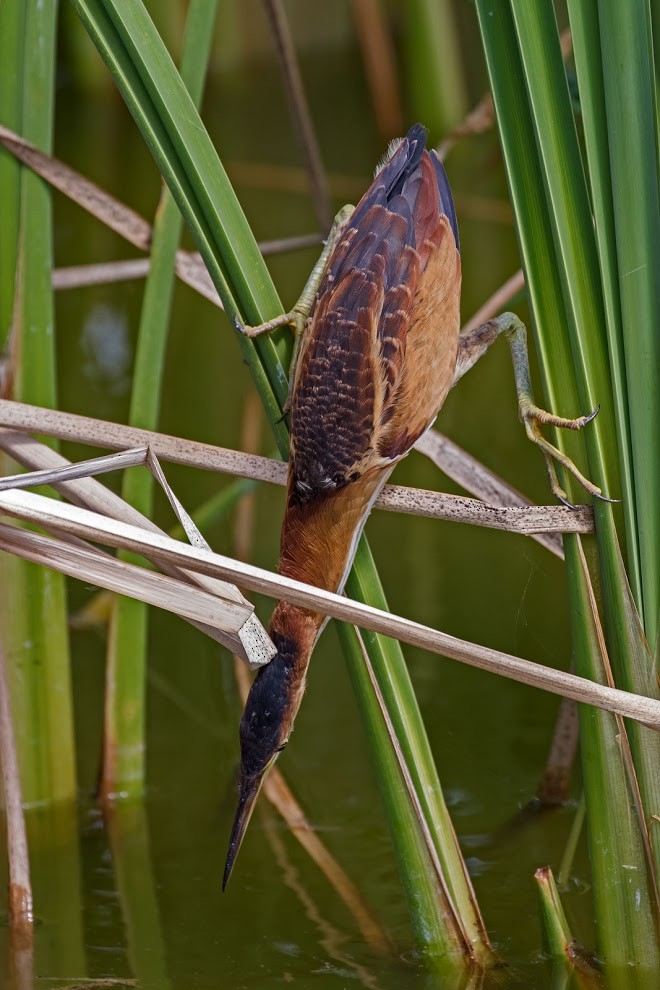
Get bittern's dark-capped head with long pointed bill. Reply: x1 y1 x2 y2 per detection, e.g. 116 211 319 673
222 637 297 890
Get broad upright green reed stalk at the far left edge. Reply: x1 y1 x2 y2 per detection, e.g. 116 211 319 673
0 0 76 805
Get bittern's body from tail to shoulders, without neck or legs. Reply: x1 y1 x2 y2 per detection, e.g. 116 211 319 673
289 125 461 504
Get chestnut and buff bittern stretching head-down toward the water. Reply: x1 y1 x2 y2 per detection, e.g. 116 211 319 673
223 125 600 889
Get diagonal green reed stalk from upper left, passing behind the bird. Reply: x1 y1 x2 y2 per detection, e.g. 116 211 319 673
73 0 490 967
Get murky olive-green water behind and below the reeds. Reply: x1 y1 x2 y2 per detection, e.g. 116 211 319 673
3 27 636 990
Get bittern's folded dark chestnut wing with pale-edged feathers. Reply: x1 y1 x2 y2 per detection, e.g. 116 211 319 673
291 197 418 501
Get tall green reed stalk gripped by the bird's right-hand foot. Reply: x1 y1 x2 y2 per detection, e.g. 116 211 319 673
477 0 660 968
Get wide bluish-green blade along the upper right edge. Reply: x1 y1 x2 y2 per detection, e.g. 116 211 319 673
598 0 660 647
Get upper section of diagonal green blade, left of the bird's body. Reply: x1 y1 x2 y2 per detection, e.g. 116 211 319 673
72 0 288 446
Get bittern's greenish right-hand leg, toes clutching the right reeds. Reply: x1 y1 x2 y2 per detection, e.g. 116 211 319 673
454 313 609 505
